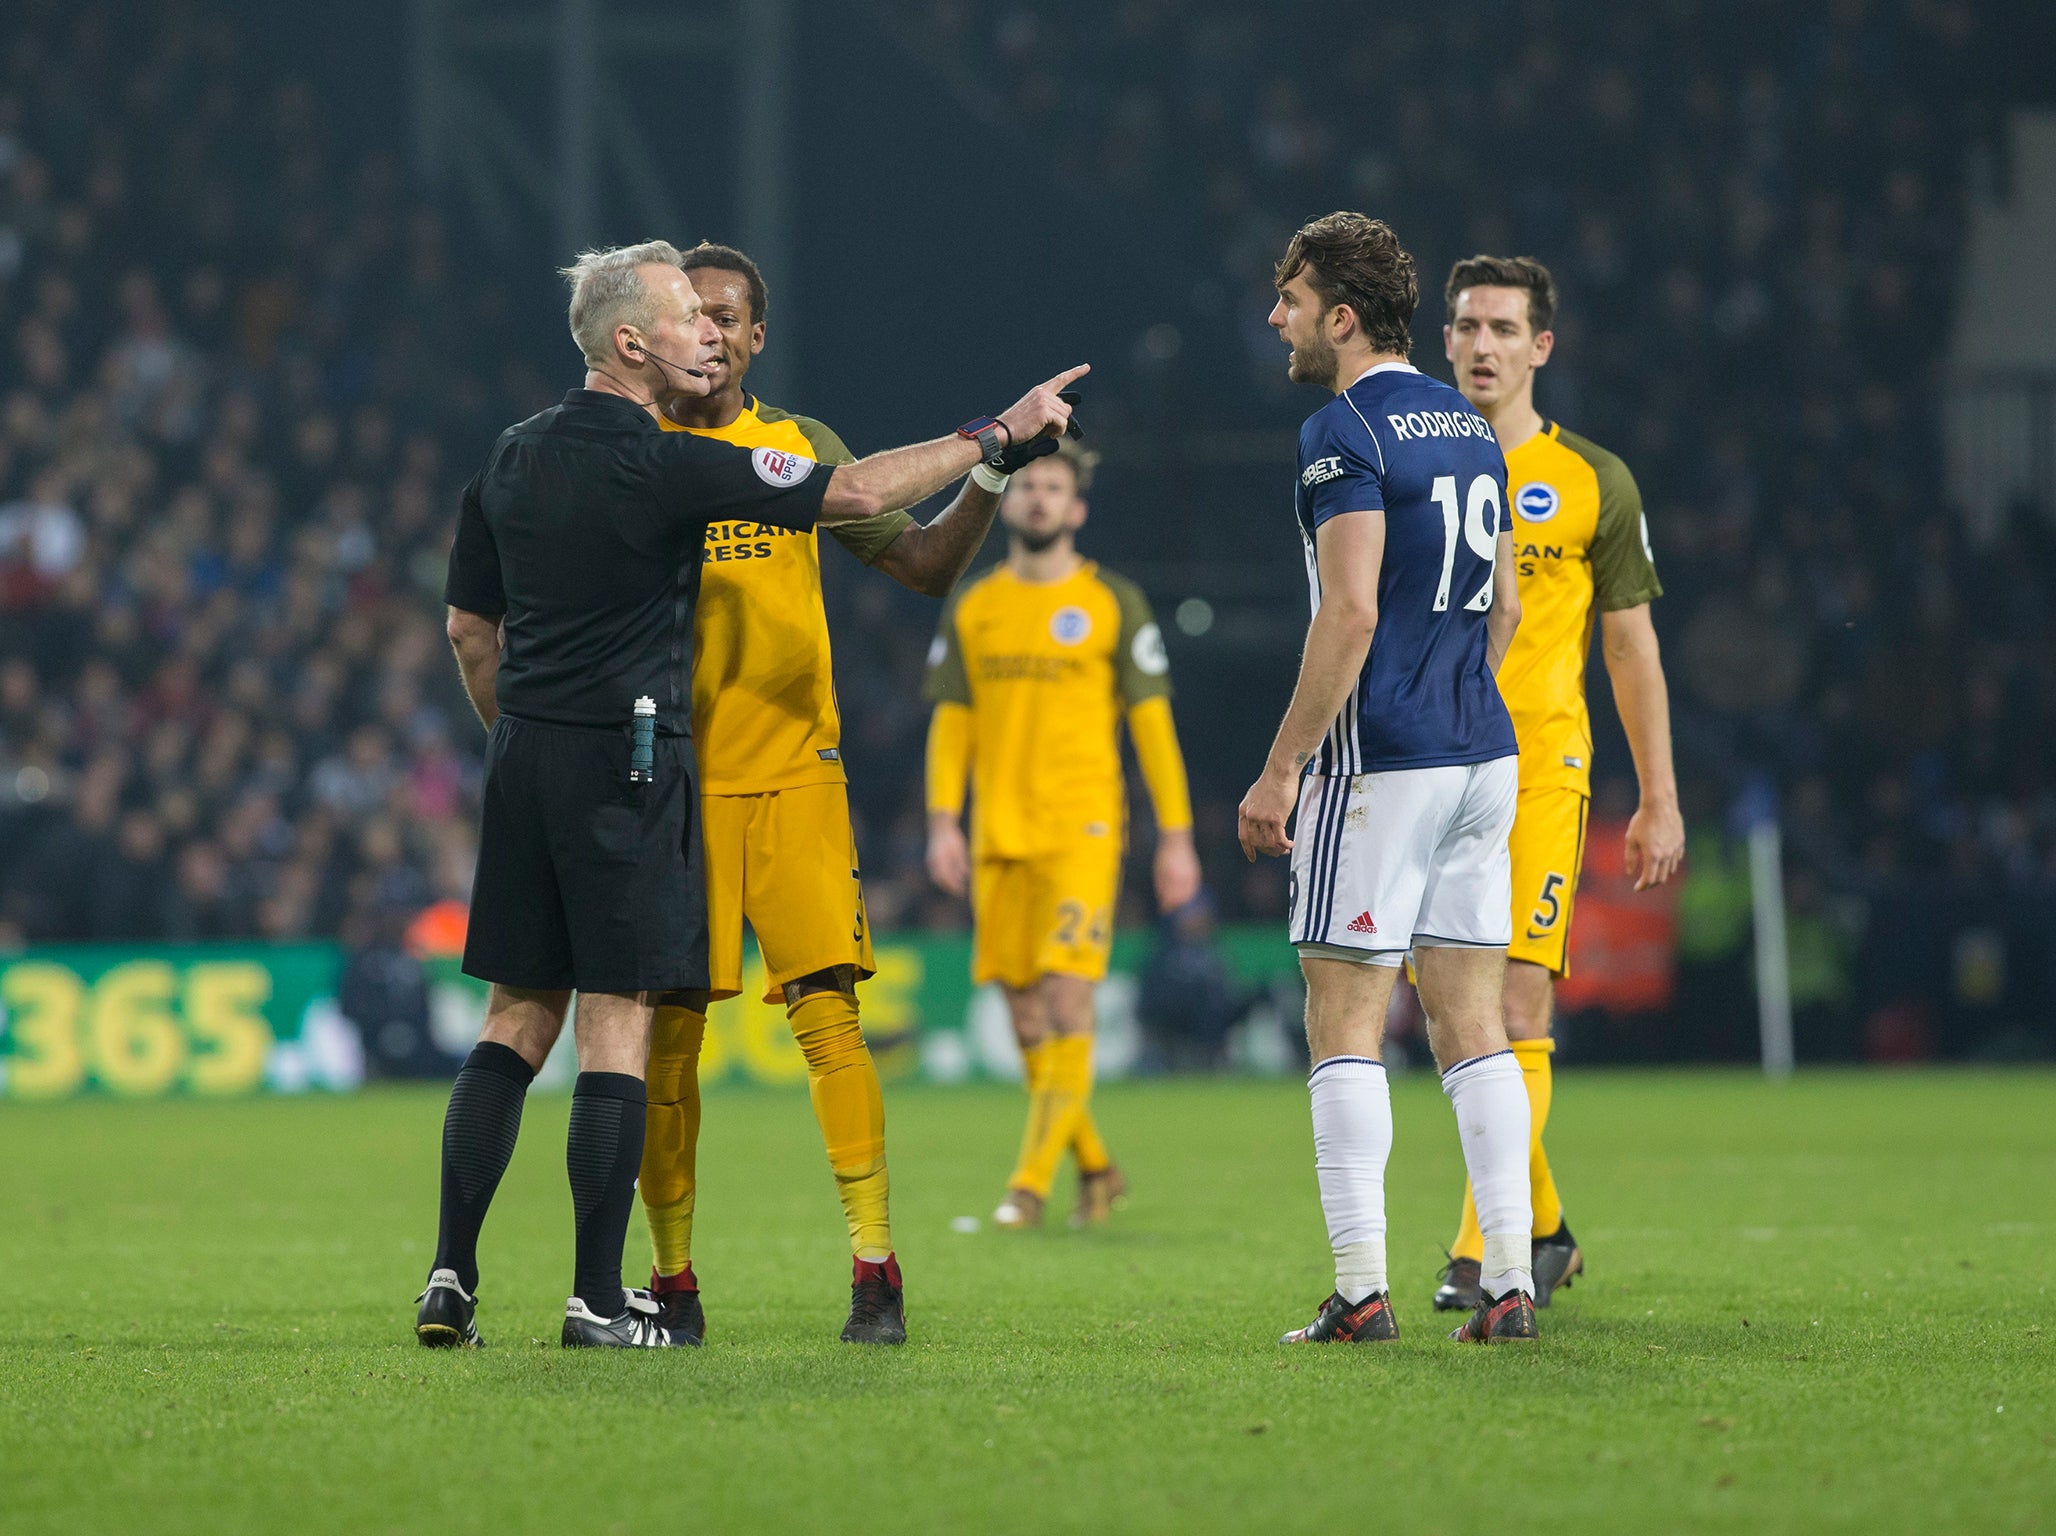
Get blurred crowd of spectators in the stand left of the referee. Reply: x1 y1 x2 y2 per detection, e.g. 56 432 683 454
0 8 547 942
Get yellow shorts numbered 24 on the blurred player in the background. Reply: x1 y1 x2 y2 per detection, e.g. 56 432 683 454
970 837 1121 987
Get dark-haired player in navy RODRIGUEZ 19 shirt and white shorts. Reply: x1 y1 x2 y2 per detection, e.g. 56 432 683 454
1240 214 1536 1343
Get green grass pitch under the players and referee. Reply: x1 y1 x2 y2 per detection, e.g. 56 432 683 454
0 1071 2056 1536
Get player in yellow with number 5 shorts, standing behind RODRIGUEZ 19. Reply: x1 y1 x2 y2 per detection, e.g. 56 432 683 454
1435 255 1684 1310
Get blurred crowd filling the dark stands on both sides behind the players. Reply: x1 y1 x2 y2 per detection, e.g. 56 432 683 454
0 0 2056 1061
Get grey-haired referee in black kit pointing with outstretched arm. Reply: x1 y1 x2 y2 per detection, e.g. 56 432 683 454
415 241 1086 1347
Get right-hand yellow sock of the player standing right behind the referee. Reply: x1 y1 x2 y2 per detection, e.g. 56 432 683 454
785 991 892 1263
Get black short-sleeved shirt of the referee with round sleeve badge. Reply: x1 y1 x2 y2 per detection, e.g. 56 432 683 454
442 389 833 736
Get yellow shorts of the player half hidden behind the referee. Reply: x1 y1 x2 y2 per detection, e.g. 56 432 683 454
699 783 876 1003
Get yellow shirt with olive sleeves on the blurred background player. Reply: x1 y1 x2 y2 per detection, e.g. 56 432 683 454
921 561 1170 860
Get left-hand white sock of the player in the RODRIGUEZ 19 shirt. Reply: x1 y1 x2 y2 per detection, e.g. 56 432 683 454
1306 1057 1389 1306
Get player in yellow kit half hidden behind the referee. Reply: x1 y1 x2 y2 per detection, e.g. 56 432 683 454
641 245 1055 1345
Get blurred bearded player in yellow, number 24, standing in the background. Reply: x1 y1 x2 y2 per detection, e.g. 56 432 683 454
923 442 1199 1230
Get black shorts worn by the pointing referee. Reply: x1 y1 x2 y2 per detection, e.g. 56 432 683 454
465 716 707 991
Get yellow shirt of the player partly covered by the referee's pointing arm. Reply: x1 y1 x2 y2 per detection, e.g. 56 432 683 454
662 395 913 794
